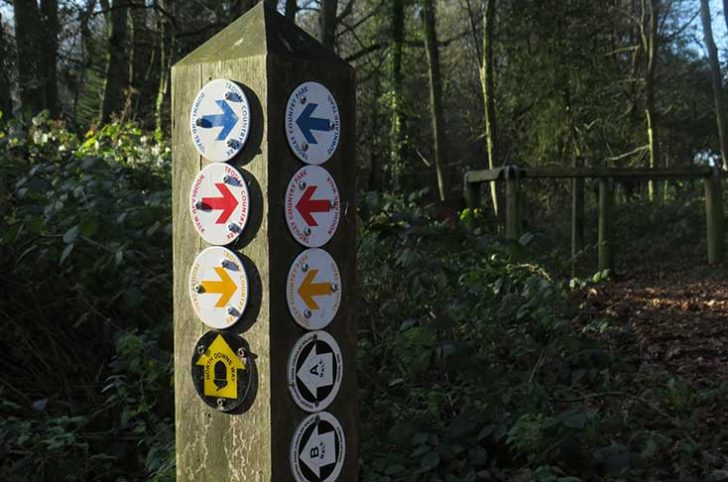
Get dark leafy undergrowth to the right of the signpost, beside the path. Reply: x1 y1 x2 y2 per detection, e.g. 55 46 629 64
359 195 728 482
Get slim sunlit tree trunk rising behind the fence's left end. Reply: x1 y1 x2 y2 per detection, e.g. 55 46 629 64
480 0 498 216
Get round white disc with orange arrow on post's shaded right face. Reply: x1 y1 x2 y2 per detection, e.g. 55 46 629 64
286 248 341 330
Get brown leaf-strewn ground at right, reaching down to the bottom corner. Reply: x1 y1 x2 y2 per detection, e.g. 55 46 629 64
586 257 728 480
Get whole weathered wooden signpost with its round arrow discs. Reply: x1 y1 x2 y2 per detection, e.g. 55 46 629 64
172 3 358 482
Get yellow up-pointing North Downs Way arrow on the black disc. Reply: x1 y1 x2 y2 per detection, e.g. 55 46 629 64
195 335 246 398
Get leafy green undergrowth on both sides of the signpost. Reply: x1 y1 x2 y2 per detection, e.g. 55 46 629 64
0 118 728 482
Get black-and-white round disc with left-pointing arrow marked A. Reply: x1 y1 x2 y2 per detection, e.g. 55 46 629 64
288 331 343 412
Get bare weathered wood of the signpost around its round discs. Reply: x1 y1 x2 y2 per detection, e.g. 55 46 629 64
172 2 358 482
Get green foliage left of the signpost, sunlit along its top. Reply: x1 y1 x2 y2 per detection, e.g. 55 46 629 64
0 115 173 480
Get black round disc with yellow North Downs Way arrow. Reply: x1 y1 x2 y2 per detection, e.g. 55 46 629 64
192 331 252 412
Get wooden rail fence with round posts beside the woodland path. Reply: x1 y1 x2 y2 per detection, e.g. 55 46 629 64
464 165 725 271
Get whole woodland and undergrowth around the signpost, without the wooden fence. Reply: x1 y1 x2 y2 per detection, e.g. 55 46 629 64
0 0 728 482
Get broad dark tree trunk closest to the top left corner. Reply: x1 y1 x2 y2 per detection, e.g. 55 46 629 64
13 0 45 114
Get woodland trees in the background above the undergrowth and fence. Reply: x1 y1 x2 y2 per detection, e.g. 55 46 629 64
0 0 728 202
